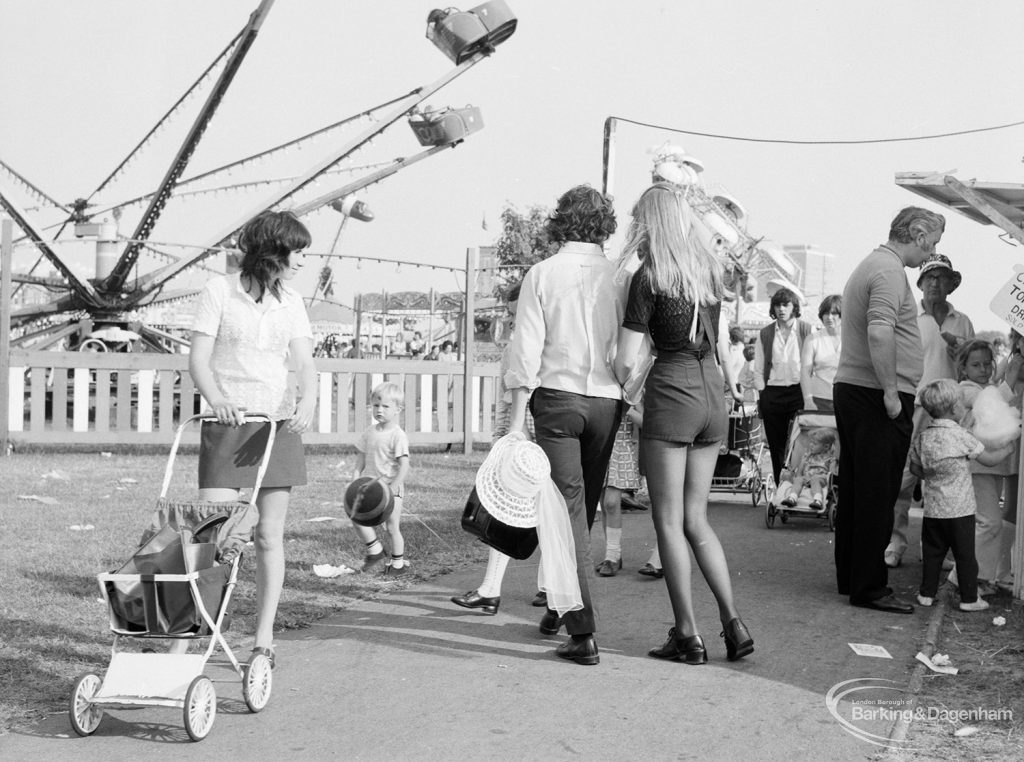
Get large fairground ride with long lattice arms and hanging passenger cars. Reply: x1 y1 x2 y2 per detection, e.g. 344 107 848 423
0 0 517 352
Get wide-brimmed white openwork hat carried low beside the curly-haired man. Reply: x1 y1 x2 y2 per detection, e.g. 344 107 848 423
476 432 551 527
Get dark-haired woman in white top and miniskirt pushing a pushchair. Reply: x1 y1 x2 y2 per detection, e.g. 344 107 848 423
188 207 316 666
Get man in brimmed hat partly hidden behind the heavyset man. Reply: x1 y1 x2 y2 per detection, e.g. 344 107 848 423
885 254 974 568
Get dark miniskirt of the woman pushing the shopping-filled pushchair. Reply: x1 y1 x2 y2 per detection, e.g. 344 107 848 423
199 420 306 490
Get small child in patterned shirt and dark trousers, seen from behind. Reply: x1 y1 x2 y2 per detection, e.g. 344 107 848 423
910 378 1013 611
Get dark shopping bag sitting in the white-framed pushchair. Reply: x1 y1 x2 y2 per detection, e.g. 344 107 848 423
104 513 230 635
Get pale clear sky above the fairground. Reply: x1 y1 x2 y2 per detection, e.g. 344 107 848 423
0 0 1024 330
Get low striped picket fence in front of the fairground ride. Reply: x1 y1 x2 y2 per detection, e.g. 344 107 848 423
6 349 499 449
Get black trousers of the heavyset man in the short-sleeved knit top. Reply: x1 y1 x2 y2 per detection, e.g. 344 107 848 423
833 383 913 603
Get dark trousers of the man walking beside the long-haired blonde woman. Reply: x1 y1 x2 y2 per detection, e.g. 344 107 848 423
529 388 622 635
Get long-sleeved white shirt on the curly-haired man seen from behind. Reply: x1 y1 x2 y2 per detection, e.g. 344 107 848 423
505 241 624 399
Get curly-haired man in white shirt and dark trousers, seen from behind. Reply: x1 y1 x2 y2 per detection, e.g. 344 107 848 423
505 185 623 665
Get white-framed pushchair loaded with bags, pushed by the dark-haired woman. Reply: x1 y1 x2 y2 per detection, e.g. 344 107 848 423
69 415 274 740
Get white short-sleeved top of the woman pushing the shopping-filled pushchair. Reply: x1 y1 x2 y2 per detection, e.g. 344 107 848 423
191 273 313 421
